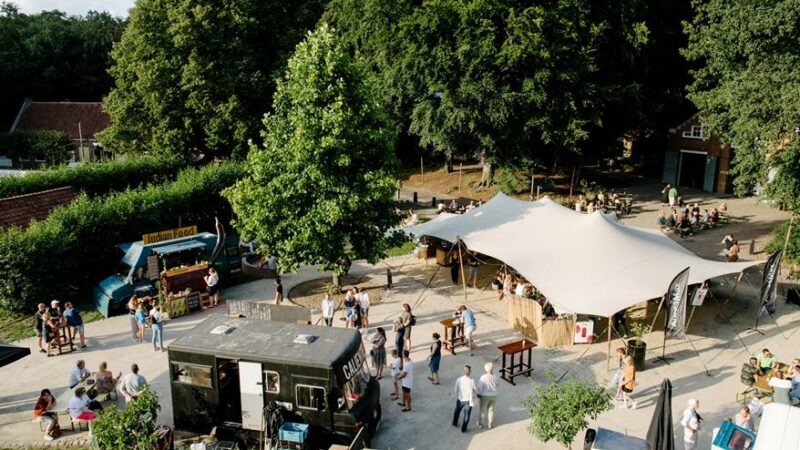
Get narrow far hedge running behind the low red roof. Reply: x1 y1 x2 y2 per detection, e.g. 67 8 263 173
0 156 185 198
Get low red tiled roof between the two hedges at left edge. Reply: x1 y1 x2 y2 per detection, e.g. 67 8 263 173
0 186 78 229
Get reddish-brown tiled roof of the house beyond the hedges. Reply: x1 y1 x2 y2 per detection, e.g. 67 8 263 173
15 102 111 139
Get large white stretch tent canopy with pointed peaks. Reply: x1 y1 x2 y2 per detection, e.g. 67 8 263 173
404 194 759 317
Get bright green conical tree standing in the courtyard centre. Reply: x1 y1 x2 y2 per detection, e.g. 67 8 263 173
226 24 397 278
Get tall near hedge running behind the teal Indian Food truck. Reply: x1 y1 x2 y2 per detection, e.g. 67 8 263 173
0 163 244 312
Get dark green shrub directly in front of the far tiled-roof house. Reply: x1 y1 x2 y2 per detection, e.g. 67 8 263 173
0 130 72 165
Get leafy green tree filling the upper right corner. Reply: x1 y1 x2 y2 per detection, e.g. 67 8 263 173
686 0 800 211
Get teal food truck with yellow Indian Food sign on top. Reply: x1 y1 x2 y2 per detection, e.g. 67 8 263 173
93 227 241 317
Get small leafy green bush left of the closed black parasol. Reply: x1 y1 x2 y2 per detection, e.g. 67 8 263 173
524 374 612 449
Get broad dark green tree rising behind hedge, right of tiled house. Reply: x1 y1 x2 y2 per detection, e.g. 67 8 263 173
103 0 324 158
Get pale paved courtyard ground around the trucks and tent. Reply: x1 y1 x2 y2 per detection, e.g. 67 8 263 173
0 185 800 450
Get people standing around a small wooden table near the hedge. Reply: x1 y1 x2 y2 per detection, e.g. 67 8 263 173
34 300 86 356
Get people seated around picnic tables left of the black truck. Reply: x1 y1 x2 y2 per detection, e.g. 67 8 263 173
33 360 147 441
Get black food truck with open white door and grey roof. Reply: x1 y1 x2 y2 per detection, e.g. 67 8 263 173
168 316 381 449
